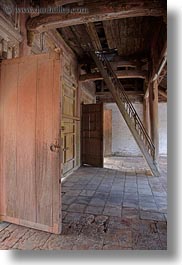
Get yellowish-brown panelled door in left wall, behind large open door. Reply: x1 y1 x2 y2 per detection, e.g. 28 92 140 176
61 56 77 177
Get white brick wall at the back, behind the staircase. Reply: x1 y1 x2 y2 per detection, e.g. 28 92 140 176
105 103 167 156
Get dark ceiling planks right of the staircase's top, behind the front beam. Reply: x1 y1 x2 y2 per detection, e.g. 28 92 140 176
103 17 161 56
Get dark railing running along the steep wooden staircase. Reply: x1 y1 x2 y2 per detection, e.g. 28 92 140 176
95 52 155 161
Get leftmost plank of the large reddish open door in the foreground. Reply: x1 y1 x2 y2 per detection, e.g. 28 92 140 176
0 62 18 218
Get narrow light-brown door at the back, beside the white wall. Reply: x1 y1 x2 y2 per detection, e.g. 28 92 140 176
104 109 112 156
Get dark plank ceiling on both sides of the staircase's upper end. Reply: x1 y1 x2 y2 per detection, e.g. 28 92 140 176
58 17 162 59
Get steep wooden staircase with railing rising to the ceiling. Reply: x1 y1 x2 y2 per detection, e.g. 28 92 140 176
90 51 160 176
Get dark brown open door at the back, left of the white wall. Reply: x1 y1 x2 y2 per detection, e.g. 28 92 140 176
81 104 103 167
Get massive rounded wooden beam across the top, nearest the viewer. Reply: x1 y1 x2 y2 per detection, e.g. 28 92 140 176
27 0 166 31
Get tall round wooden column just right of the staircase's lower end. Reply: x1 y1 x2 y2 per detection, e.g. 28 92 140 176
149 80 159 164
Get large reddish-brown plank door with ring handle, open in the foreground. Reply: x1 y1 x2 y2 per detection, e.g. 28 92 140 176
0 53 61 233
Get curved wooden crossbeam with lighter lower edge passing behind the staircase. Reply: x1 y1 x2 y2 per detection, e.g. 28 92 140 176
79 70 147 82
